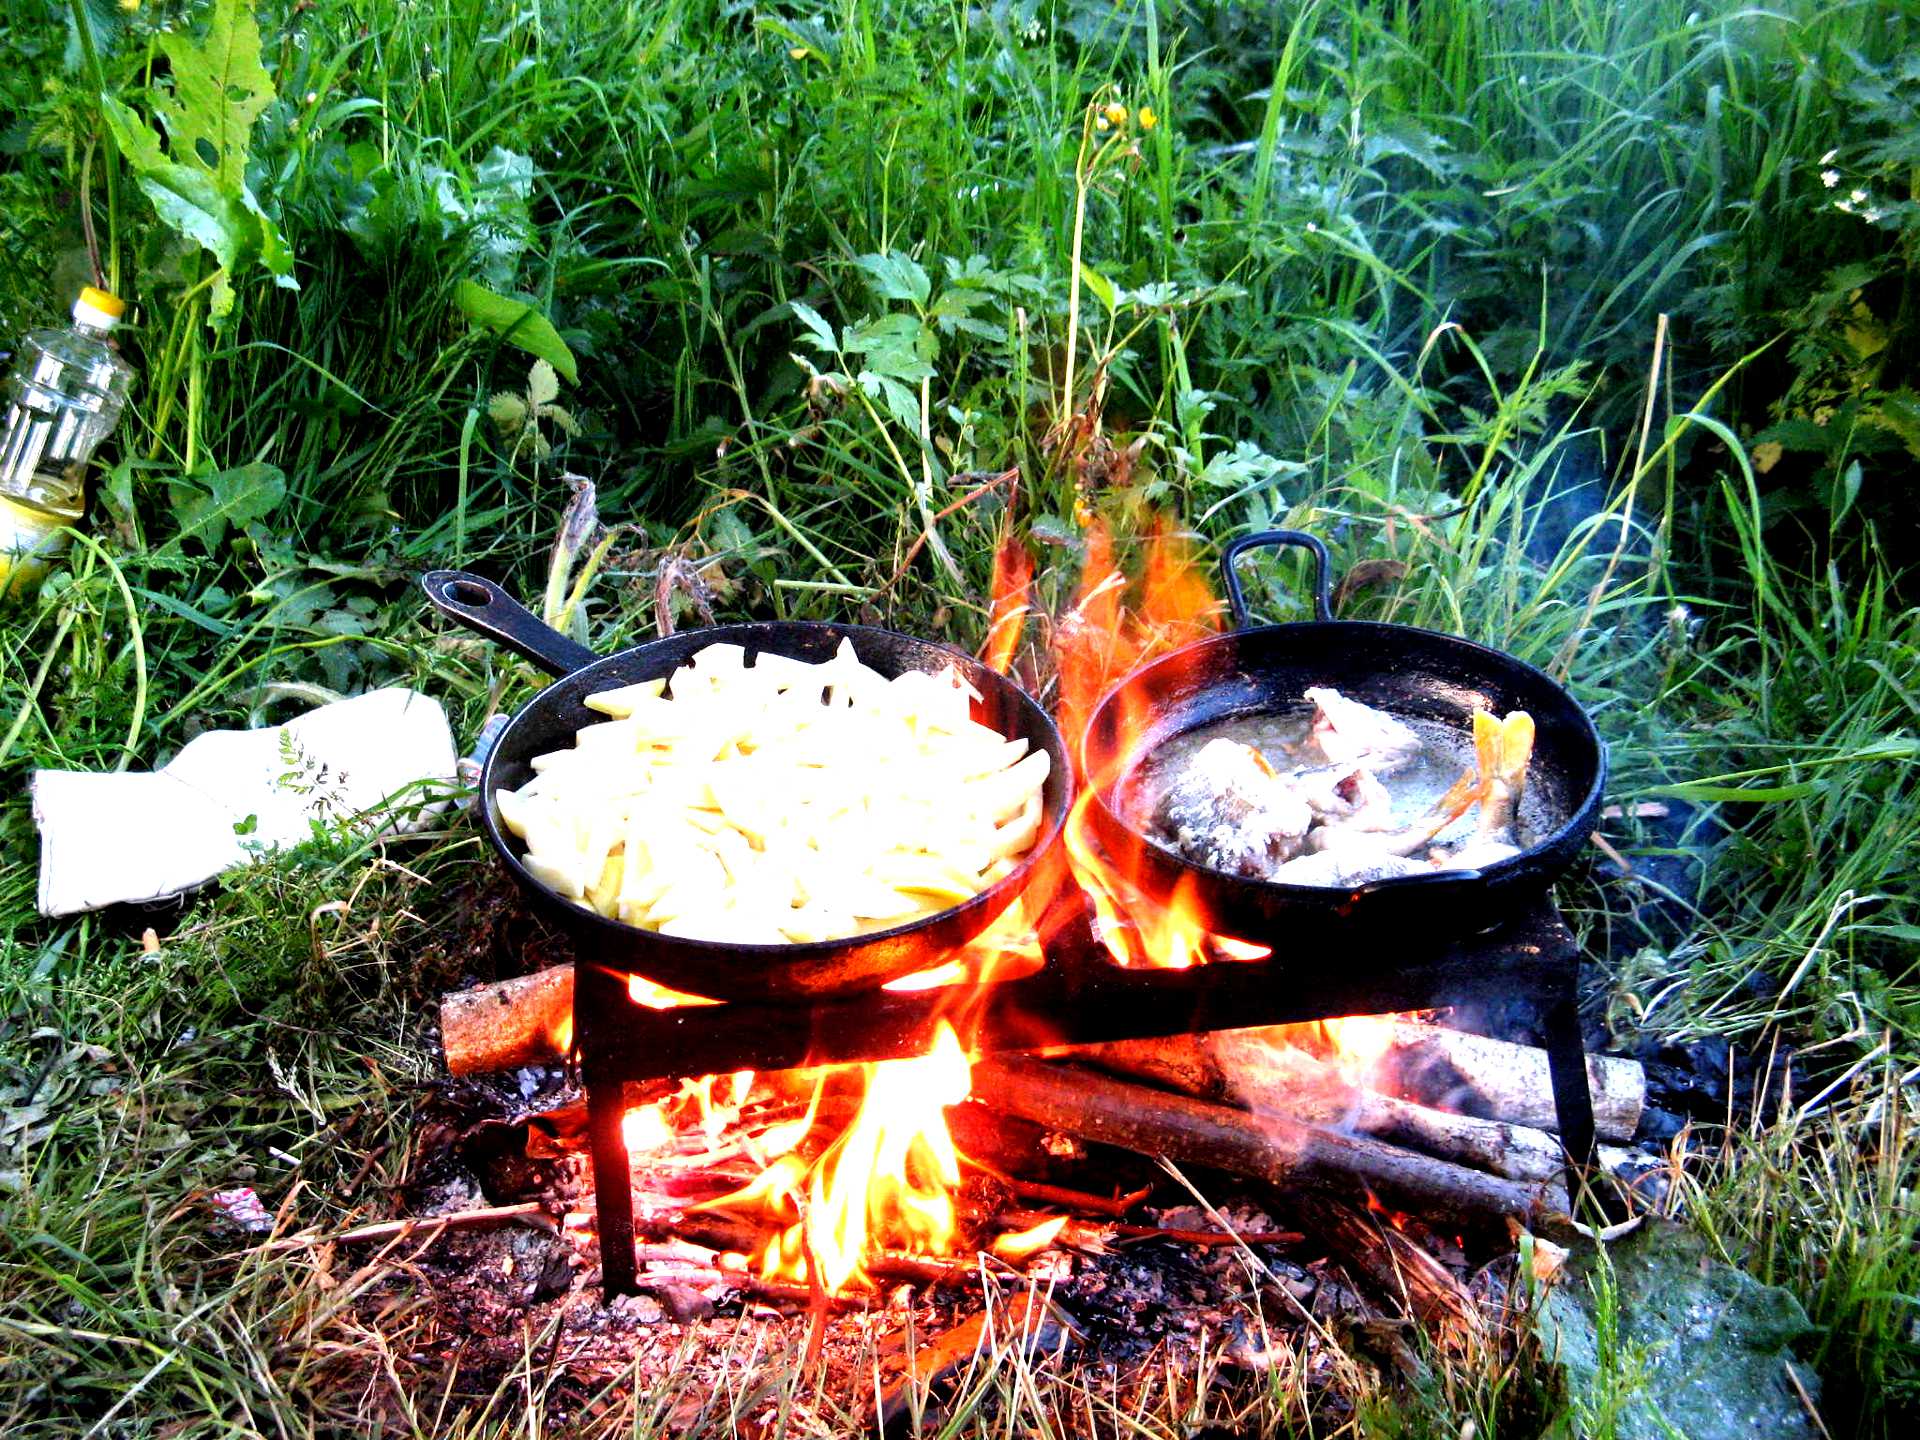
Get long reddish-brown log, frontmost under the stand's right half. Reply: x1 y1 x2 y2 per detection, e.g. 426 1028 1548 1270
973 1058 1567 1225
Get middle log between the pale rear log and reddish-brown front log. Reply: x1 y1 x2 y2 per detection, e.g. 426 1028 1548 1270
1073 1029 1642 1181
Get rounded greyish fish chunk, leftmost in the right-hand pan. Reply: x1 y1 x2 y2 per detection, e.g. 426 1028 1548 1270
1156 739 1313 879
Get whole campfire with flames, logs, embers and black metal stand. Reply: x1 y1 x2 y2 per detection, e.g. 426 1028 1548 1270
378 530 1657 1436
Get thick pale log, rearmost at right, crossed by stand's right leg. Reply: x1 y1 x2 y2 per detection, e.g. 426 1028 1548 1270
1384 1023 1647 1142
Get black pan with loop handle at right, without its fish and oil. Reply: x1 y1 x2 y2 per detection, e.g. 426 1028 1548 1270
1081 530 1607 950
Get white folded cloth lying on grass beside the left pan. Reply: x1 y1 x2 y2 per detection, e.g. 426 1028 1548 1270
33 689 455 916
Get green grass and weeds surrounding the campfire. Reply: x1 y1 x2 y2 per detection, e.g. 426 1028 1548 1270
0 0 1920 1436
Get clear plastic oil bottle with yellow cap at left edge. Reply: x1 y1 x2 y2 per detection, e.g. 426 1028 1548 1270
0 286 132 599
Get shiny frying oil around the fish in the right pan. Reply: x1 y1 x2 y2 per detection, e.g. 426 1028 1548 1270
1121 705 1567 849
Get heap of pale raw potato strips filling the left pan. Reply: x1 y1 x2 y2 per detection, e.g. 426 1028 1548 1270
495 641 1048 945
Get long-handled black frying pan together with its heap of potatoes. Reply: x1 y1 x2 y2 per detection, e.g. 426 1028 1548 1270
420 570 1071 1000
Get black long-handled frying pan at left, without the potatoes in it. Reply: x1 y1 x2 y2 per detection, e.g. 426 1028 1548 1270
420 570 1073 1002
